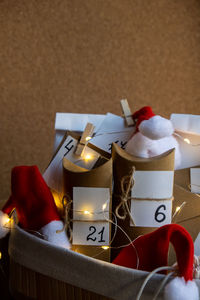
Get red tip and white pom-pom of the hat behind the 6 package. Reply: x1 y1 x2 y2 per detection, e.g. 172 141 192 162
132 106 174 140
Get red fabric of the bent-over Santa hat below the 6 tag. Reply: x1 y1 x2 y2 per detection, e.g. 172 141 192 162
113 224 194 281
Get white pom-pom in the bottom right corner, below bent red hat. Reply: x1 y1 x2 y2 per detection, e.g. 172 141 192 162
164 277 199 300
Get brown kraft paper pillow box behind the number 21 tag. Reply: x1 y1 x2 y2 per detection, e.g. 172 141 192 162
63 158 112 261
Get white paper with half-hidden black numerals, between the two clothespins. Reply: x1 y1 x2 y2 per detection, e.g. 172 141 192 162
90 113 135 153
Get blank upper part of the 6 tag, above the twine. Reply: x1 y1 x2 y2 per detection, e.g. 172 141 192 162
132 171 174 199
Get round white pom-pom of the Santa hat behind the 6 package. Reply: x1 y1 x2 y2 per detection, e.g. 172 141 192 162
139 116 174 140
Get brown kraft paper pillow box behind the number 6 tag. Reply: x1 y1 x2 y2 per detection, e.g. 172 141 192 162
112 144 174 259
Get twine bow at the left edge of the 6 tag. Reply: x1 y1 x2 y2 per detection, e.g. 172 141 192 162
115 167 135 225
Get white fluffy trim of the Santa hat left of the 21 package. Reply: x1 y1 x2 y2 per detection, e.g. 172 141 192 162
39 221 70 249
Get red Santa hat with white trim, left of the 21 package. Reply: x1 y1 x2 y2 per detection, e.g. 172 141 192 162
0 166 70 248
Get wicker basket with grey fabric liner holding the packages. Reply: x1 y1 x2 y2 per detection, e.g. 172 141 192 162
9 226 192 300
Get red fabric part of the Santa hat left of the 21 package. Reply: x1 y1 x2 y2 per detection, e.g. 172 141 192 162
2 166 60 231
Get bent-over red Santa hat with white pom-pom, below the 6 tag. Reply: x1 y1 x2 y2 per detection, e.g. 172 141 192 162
113 224 199 300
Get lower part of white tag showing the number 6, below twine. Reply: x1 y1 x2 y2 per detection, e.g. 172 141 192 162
130 200 172 227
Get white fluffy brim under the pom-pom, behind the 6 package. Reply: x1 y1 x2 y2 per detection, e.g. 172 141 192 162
126 132 181 169
